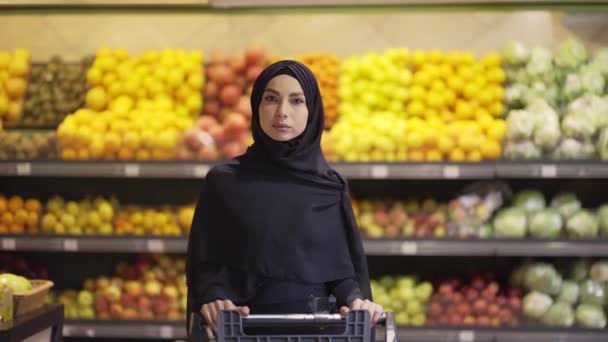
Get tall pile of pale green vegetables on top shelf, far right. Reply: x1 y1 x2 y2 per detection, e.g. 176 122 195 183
504 38 608 159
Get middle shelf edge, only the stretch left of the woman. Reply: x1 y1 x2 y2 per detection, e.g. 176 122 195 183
0 235 187 253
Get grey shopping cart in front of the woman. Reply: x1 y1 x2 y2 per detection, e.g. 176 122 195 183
190 310 397 342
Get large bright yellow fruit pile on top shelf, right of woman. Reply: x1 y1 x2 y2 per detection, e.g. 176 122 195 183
328 49 506 161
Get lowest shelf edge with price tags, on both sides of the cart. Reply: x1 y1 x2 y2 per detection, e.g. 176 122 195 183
63 321 608 342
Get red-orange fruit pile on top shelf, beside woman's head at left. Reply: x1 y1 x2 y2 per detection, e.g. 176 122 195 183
178 45 266 160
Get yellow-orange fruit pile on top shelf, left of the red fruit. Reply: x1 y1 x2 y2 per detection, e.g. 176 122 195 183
57 48 205 160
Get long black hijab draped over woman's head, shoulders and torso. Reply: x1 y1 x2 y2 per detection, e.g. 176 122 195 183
188 61 372 314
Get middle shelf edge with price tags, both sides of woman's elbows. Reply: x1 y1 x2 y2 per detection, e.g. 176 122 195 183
0 235 608 257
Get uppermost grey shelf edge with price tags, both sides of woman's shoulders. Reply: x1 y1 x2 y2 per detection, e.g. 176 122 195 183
0 161 608 179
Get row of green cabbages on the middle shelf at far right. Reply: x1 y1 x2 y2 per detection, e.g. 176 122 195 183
493 189 608 239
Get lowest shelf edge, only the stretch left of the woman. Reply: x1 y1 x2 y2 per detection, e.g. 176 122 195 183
63 320 186 339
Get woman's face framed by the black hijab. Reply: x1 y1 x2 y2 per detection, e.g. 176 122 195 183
259 75 308 141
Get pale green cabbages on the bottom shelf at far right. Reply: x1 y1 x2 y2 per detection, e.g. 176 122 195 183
511 259 608 329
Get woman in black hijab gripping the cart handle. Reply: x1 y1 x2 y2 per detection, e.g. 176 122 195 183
187 61 382 329
